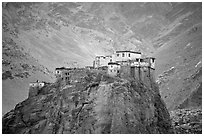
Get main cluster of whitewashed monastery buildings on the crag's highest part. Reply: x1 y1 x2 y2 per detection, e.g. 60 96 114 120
93 51 155 80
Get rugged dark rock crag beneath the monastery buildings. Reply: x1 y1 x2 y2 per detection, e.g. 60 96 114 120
2 73 173 134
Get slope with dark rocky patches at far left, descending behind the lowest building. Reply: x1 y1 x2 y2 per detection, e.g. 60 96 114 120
2 29 53 114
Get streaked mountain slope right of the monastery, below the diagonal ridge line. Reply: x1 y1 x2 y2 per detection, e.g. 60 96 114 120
155 9 202 109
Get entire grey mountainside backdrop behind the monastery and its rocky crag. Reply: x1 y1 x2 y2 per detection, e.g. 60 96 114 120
2 2 202 117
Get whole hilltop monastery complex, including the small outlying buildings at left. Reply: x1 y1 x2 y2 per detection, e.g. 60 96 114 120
28 51 155 97
